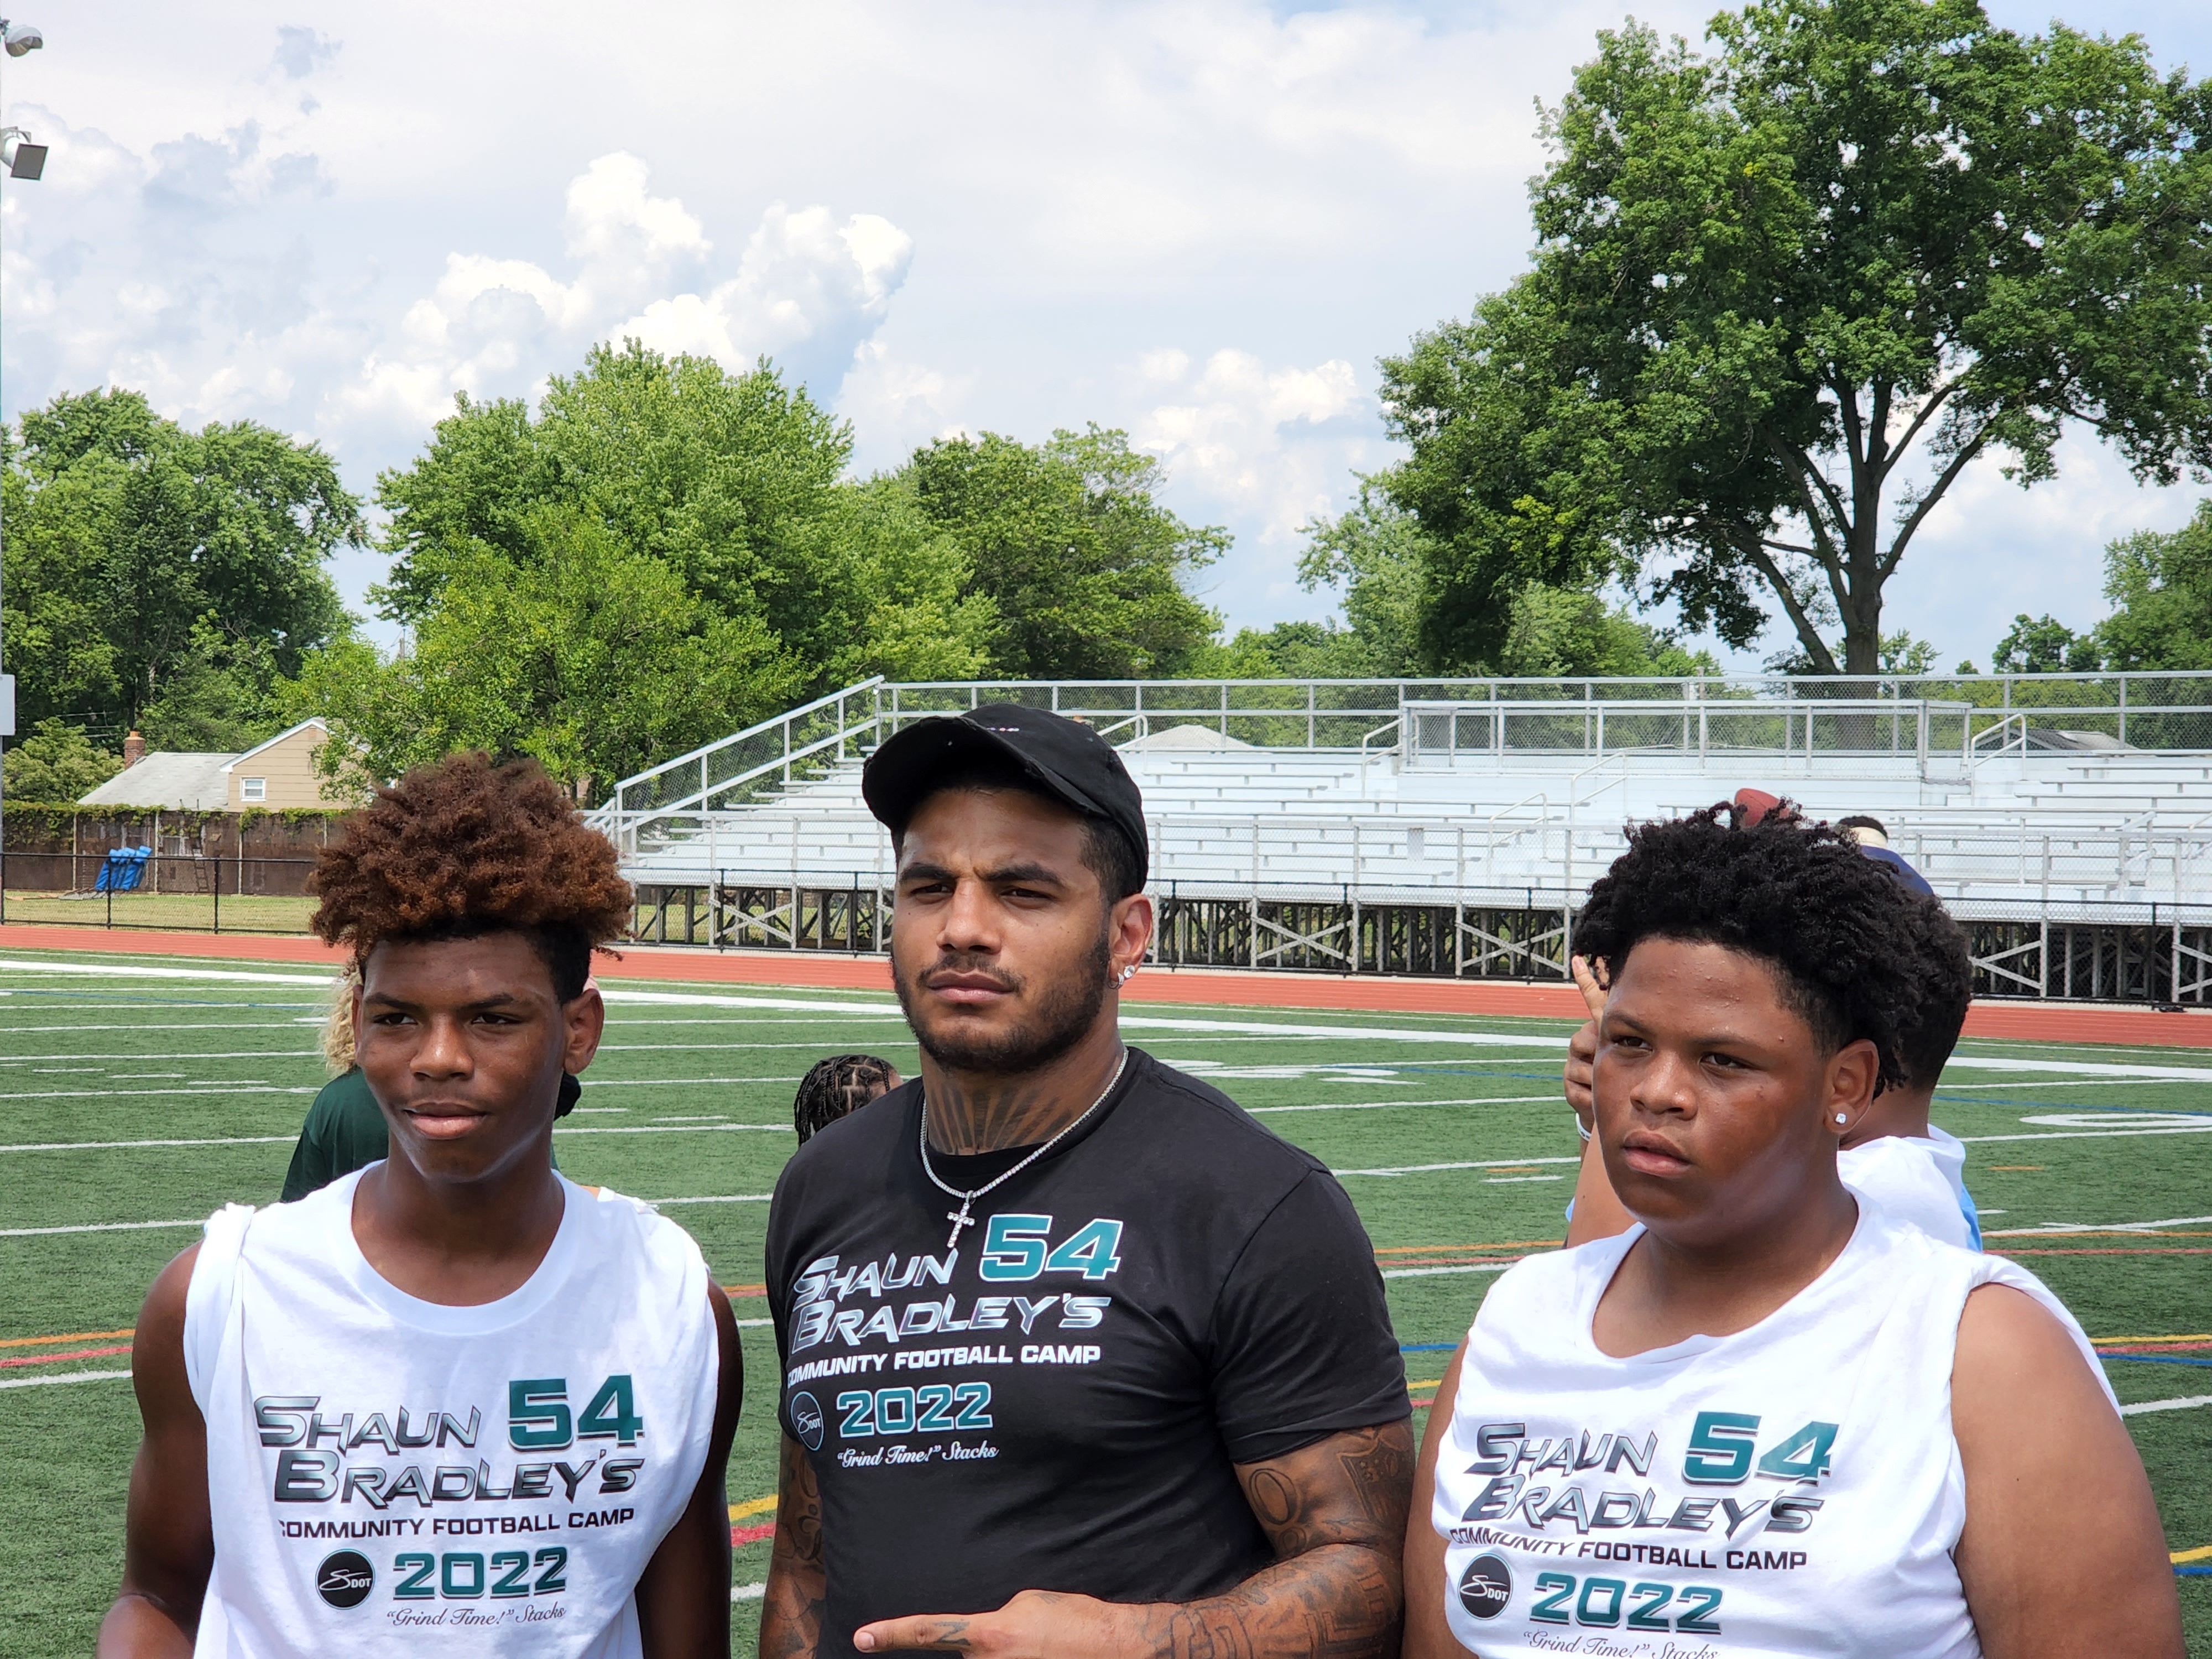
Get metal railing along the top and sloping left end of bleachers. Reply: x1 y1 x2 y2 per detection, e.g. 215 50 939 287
593 672 2212 858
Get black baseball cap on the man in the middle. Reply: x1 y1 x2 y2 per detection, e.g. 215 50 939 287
860 703 1150 885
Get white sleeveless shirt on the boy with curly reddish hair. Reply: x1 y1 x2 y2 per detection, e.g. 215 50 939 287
184 1166 719 1659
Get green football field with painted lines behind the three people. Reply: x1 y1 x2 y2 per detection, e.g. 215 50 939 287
0 953 2212 1659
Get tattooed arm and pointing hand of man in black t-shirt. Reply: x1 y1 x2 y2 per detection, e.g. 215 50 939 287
854 1422 1413 1659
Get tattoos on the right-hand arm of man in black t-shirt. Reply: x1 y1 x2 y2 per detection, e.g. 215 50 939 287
1144 1422 1413 1659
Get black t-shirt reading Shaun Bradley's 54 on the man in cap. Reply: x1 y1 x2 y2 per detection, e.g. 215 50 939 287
768 1048 1409 1655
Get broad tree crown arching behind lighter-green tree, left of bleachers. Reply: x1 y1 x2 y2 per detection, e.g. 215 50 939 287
374 341 995 708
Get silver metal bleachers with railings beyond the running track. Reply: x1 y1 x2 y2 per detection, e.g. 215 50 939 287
595 675 2212 1002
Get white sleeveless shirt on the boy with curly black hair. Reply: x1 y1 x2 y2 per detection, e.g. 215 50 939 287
1431 1199 2110 1659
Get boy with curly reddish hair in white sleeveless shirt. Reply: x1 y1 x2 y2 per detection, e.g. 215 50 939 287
100 754 741 1659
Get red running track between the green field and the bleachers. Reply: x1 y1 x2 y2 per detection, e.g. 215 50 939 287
0 922 2212 1048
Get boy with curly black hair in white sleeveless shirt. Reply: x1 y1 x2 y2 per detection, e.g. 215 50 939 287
1405 814 2181 1659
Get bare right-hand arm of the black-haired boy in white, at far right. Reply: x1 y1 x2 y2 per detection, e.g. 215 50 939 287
1951 1285 2181 1659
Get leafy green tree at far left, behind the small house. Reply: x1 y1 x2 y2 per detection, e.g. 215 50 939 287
4 392 363 741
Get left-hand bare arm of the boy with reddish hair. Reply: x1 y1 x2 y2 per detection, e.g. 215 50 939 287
97 1245 215 1659
